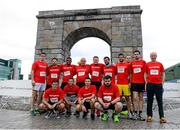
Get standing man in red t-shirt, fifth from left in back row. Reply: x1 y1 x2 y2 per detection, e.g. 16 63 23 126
90 56 104 92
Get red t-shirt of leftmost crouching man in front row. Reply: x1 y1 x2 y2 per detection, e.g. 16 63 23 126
43 88 64 103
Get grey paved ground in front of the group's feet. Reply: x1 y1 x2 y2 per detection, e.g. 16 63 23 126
0 109 180 129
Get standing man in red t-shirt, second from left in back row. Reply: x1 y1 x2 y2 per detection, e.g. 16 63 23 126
46 58 61 90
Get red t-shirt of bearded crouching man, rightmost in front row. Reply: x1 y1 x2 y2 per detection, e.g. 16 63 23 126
98 85 120 103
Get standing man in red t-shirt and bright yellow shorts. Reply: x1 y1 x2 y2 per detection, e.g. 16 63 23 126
116 53 131 118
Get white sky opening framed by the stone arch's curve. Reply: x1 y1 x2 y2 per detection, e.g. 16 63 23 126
71 37 110 64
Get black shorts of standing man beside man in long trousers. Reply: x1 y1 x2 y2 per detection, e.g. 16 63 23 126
131 83 145 92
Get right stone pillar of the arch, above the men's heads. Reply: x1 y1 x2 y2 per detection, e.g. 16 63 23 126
111 6 142 62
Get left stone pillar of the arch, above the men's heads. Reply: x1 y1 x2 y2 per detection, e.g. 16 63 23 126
35 11 65 63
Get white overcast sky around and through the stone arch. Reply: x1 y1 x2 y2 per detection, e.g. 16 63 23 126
0 0 180 79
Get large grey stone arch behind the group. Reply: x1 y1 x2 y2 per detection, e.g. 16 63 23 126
35 6 143 63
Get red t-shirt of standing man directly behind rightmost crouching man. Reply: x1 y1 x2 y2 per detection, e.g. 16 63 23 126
103 65 116 84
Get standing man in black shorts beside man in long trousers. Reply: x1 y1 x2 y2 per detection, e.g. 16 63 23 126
130 50 146 121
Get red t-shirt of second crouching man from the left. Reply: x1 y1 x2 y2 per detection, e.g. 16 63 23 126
64 84 79 95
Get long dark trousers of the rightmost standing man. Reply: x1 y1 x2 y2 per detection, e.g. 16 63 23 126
147 83 164 118
